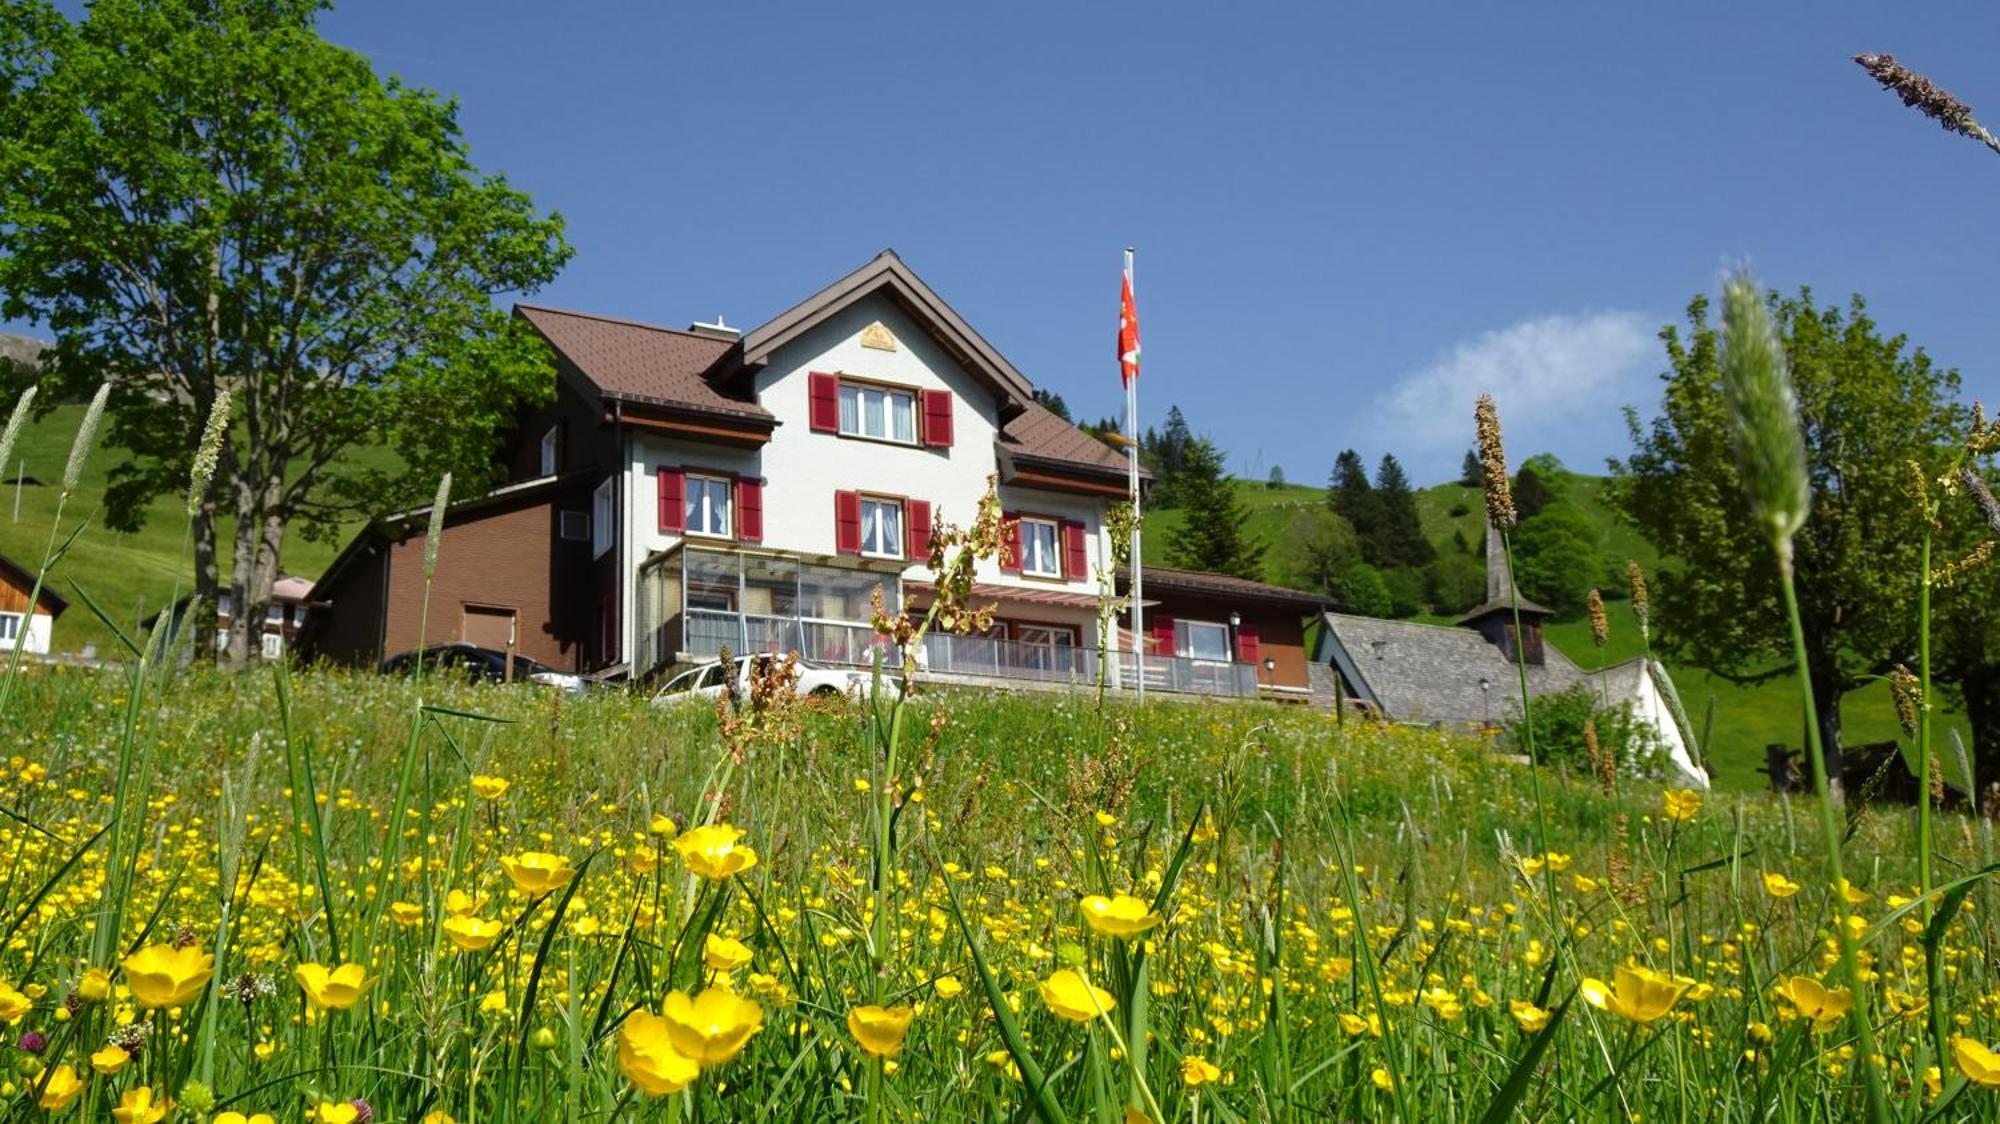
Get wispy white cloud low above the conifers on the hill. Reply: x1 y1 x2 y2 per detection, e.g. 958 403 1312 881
1376 312 1664 472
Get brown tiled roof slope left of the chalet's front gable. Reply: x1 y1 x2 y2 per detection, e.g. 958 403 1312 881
514 304 770 420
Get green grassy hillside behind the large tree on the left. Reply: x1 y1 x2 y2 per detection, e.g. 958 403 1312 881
0 406 378 652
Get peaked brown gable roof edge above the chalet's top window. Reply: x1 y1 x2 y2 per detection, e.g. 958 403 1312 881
740 250 1034 420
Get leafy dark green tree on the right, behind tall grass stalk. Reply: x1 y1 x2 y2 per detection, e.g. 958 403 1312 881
1610 290 1962 776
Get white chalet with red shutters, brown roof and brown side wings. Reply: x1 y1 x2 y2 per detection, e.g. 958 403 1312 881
300 252 1318 694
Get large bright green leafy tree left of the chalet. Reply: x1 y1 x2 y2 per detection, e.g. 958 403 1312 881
0 0 570 658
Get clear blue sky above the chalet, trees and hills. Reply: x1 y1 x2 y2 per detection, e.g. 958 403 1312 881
23 0 2000 482
